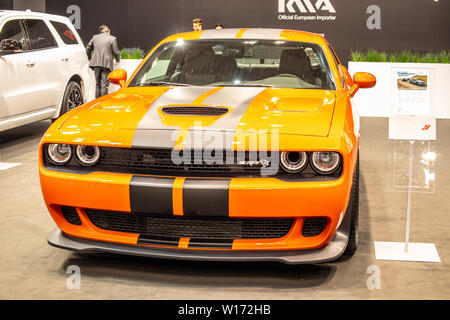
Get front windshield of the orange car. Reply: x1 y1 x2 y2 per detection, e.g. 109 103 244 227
129 39 335 90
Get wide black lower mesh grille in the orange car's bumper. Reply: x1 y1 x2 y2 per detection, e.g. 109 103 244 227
86 209 294 240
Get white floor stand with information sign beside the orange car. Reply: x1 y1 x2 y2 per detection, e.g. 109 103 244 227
374 68 441 263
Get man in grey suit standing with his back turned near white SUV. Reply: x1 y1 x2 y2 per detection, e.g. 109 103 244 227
86 25 120 98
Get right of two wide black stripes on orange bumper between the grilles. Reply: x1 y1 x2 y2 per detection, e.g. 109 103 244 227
183 179 231 217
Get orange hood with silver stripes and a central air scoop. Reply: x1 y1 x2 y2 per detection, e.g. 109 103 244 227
60 87 335 137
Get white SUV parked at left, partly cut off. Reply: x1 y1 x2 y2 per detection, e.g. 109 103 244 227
0 11 90 131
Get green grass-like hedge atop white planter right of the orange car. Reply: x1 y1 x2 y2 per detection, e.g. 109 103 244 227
350 49 450 63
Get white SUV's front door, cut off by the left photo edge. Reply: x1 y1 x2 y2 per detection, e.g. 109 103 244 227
0 19 37 120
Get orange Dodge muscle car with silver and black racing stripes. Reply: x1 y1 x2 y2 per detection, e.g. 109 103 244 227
39 29 376 264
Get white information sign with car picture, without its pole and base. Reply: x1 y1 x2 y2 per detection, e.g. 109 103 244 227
389 68 436 140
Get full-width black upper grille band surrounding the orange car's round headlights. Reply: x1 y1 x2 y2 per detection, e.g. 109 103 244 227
43 145 342 181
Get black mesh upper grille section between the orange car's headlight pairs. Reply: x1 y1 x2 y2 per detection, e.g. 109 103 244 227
98 147 271 177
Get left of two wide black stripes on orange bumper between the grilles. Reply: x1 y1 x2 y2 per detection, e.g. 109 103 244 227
130 176 175 215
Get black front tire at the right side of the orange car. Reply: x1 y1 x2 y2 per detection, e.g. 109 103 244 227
344 155 359 256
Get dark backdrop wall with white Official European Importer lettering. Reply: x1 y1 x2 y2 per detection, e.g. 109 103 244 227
46 0 450 65
